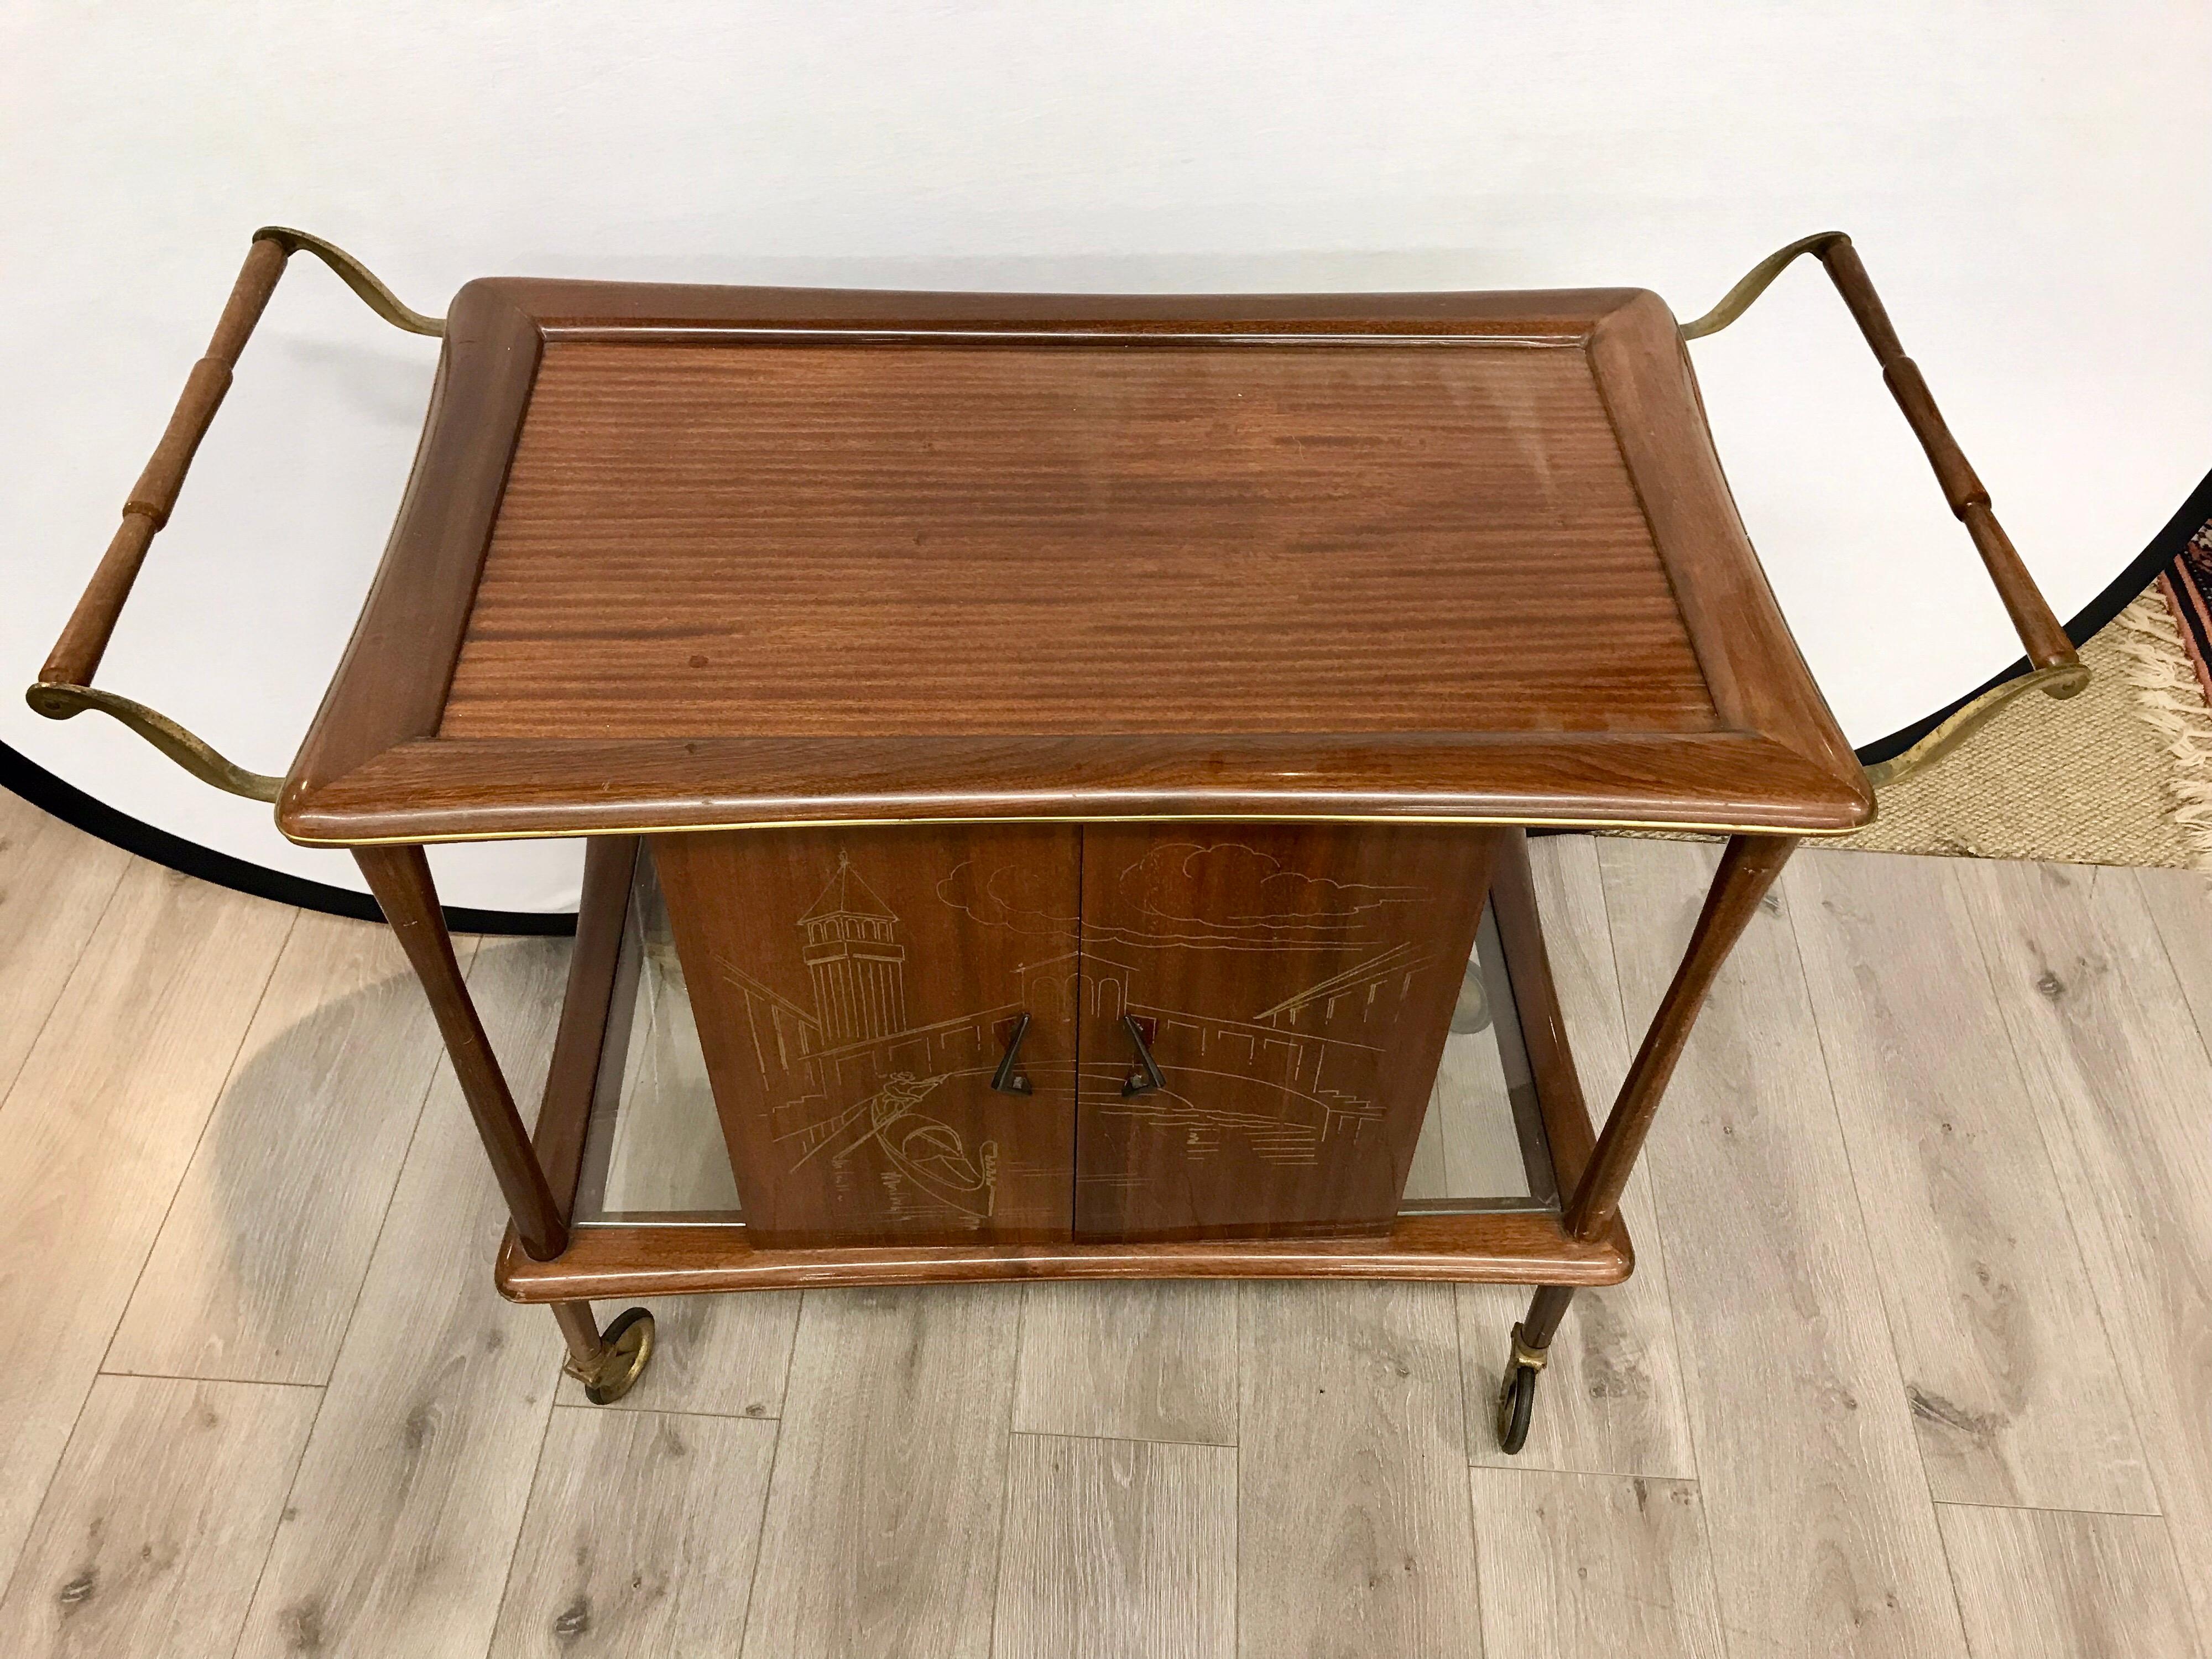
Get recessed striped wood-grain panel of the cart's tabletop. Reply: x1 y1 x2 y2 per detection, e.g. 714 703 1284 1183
438 341 1717 739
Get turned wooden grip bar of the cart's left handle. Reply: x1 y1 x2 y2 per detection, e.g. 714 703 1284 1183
38 237 290 686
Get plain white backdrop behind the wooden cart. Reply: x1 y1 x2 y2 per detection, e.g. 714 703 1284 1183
0 0 2212 907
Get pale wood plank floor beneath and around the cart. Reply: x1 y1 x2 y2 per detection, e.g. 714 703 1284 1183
13 841 2212 1659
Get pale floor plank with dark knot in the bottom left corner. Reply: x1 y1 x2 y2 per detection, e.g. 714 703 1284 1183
0 1376 321 1659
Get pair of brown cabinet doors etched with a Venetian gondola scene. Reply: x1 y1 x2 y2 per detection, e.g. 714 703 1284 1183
641 825 1504 1248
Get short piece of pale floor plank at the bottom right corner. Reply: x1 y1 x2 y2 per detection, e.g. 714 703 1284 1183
1936 1504 2199 1659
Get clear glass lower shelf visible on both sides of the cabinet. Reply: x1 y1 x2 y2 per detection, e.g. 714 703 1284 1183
575 856 1557 1225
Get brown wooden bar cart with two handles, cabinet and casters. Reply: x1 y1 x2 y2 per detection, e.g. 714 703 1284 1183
31 230 2084 1451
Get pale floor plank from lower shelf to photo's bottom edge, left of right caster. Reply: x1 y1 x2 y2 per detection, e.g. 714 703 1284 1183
1237 1283 1480 1659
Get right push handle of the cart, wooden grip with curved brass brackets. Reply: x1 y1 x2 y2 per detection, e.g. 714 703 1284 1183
1681 230 2088 783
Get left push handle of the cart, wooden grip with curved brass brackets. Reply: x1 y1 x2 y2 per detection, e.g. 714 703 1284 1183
24 226 445 801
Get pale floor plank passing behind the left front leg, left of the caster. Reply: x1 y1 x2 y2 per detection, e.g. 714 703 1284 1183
239 940 568 1659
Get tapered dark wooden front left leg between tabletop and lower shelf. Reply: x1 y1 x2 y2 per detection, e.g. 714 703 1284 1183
354 847 571 1256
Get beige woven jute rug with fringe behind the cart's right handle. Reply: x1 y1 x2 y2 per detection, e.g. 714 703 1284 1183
1832 524 2212 869
